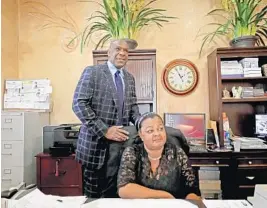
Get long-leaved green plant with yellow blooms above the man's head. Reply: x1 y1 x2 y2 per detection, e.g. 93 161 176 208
69 0 175 52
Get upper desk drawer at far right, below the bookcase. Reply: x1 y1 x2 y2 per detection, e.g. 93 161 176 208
237 158 267 169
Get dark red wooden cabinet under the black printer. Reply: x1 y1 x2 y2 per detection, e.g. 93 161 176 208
36 153 83 196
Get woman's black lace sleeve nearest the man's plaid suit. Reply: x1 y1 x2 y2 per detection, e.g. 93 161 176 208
117 147 137 188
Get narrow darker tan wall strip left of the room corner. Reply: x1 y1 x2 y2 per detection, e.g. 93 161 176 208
1 0 19 105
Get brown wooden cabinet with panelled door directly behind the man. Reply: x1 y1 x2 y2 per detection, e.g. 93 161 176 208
93 49 157 113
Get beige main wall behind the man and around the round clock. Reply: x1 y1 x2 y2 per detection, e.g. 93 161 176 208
2 0 267 124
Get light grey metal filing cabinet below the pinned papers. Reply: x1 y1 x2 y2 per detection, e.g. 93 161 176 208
1 111 49 190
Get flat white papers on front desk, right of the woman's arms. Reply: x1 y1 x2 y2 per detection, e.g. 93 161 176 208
203 199 253 208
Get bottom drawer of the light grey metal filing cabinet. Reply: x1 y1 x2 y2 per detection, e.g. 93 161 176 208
1 167 23 190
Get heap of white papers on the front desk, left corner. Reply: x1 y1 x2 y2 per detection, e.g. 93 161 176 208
7 189 87 208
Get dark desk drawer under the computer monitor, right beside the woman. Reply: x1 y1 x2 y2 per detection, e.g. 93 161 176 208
190 158 230 167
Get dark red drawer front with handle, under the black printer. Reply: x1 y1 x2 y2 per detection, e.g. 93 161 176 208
40 158 81 187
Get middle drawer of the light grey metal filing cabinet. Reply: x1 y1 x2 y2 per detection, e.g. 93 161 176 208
1 141 24 167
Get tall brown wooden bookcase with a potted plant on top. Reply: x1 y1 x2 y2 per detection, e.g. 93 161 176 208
208 47 267 145
